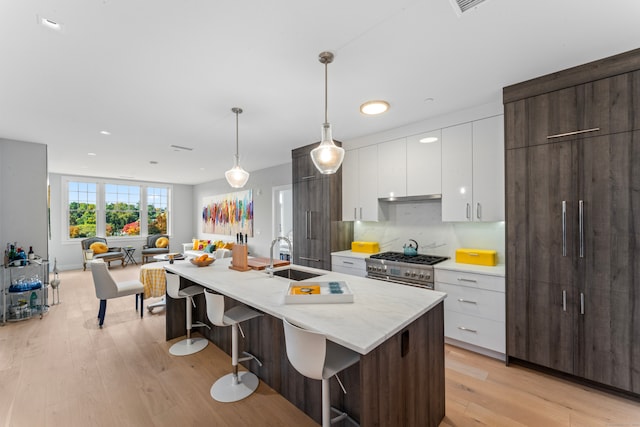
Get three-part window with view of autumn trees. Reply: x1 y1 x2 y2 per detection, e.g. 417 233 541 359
63 178 171 239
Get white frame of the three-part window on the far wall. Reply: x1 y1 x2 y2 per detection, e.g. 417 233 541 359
61 176 173 242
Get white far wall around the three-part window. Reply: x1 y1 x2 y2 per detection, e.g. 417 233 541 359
49 173 194 270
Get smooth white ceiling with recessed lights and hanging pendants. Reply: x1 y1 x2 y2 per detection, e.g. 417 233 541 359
0 0 640 184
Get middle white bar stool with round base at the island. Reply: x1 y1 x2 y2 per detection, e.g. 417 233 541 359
204 290 262 402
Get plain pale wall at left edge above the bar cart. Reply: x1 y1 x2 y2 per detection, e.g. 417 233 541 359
0 138 49 259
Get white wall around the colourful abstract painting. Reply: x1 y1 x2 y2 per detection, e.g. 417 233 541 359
190 162 291 257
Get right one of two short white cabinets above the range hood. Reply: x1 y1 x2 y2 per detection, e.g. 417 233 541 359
407 129 442 196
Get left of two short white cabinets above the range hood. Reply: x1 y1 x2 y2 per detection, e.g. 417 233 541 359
377 138 407 199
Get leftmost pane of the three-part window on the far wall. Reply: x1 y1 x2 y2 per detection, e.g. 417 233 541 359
68 182 97 239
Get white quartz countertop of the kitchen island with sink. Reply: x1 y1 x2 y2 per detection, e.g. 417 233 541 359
166 258 446 354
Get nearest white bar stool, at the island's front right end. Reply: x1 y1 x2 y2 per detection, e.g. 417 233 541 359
282 319 360 427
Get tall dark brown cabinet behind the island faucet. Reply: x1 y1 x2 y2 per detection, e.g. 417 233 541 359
291 144 353 270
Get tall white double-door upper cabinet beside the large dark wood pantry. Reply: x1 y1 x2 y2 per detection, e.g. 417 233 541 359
442 115 504 222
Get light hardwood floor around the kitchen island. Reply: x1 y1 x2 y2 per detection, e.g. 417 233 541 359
0 266 640 427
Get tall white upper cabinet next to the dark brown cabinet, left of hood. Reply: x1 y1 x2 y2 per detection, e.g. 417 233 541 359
342 145 378 221
